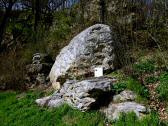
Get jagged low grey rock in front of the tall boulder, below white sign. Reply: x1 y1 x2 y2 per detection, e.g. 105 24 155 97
36 77 113 111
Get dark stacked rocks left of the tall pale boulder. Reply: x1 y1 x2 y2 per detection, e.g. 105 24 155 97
26 53 53 85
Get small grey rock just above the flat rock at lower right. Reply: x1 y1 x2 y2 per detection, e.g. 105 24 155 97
113 90 137 103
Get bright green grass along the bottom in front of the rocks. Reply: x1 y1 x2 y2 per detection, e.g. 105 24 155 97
0 91 166 126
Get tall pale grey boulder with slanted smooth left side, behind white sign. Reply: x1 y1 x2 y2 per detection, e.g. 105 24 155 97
49 24 117 83
